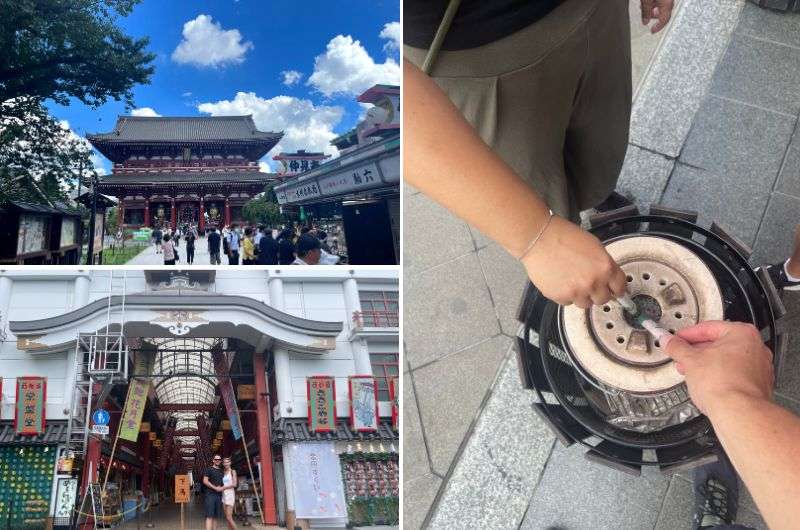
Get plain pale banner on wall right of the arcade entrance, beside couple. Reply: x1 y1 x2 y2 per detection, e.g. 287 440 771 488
284 442 347 519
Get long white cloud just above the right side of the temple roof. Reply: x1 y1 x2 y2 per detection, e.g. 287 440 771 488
197 92 344 156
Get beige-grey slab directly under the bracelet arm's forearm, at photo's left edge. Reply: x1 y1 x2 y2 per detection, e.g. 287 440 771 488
403 193 475 274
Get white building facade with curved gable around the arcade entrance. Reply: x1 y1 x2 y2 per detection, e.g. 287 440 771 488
0 267 400 527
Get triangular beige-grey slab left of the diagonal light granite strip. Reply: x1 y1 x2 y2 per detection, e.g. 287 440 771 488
412 335 511 476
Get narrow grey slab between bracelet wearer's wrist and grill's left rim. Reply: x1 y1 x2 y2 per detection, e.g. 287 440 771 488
478 243 528 336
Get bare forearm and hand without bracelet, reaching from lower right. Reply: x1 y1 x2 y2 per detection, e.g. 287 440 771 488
666 322 800 530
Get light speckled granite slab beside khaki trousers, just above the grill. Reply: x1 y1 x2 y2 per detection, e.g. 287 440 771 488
617 145 675 207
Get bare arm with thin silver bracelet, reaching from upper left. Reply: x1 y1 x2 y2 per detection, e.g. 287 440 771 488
403 60 626 308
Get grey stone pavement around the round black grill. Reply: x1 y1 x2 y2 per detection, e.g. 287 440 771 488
403 0 800 529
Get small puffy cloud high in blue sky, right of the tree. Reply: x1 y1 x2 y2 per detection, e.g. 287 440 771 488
172 15 253 66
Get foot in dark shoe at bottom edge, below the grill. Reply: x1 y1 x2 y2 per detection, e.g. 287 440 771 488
692 452 739 530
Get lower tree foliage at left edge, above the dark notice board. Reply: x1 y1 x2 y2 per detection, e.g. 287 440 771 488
0 98 93 203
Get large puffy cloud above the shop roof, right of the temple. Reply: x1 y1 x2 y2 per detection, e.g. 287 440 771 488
306 33 400 96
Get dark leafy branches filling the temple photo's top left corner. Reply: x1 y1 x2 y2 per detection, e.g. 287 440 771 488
0 0 155 107
